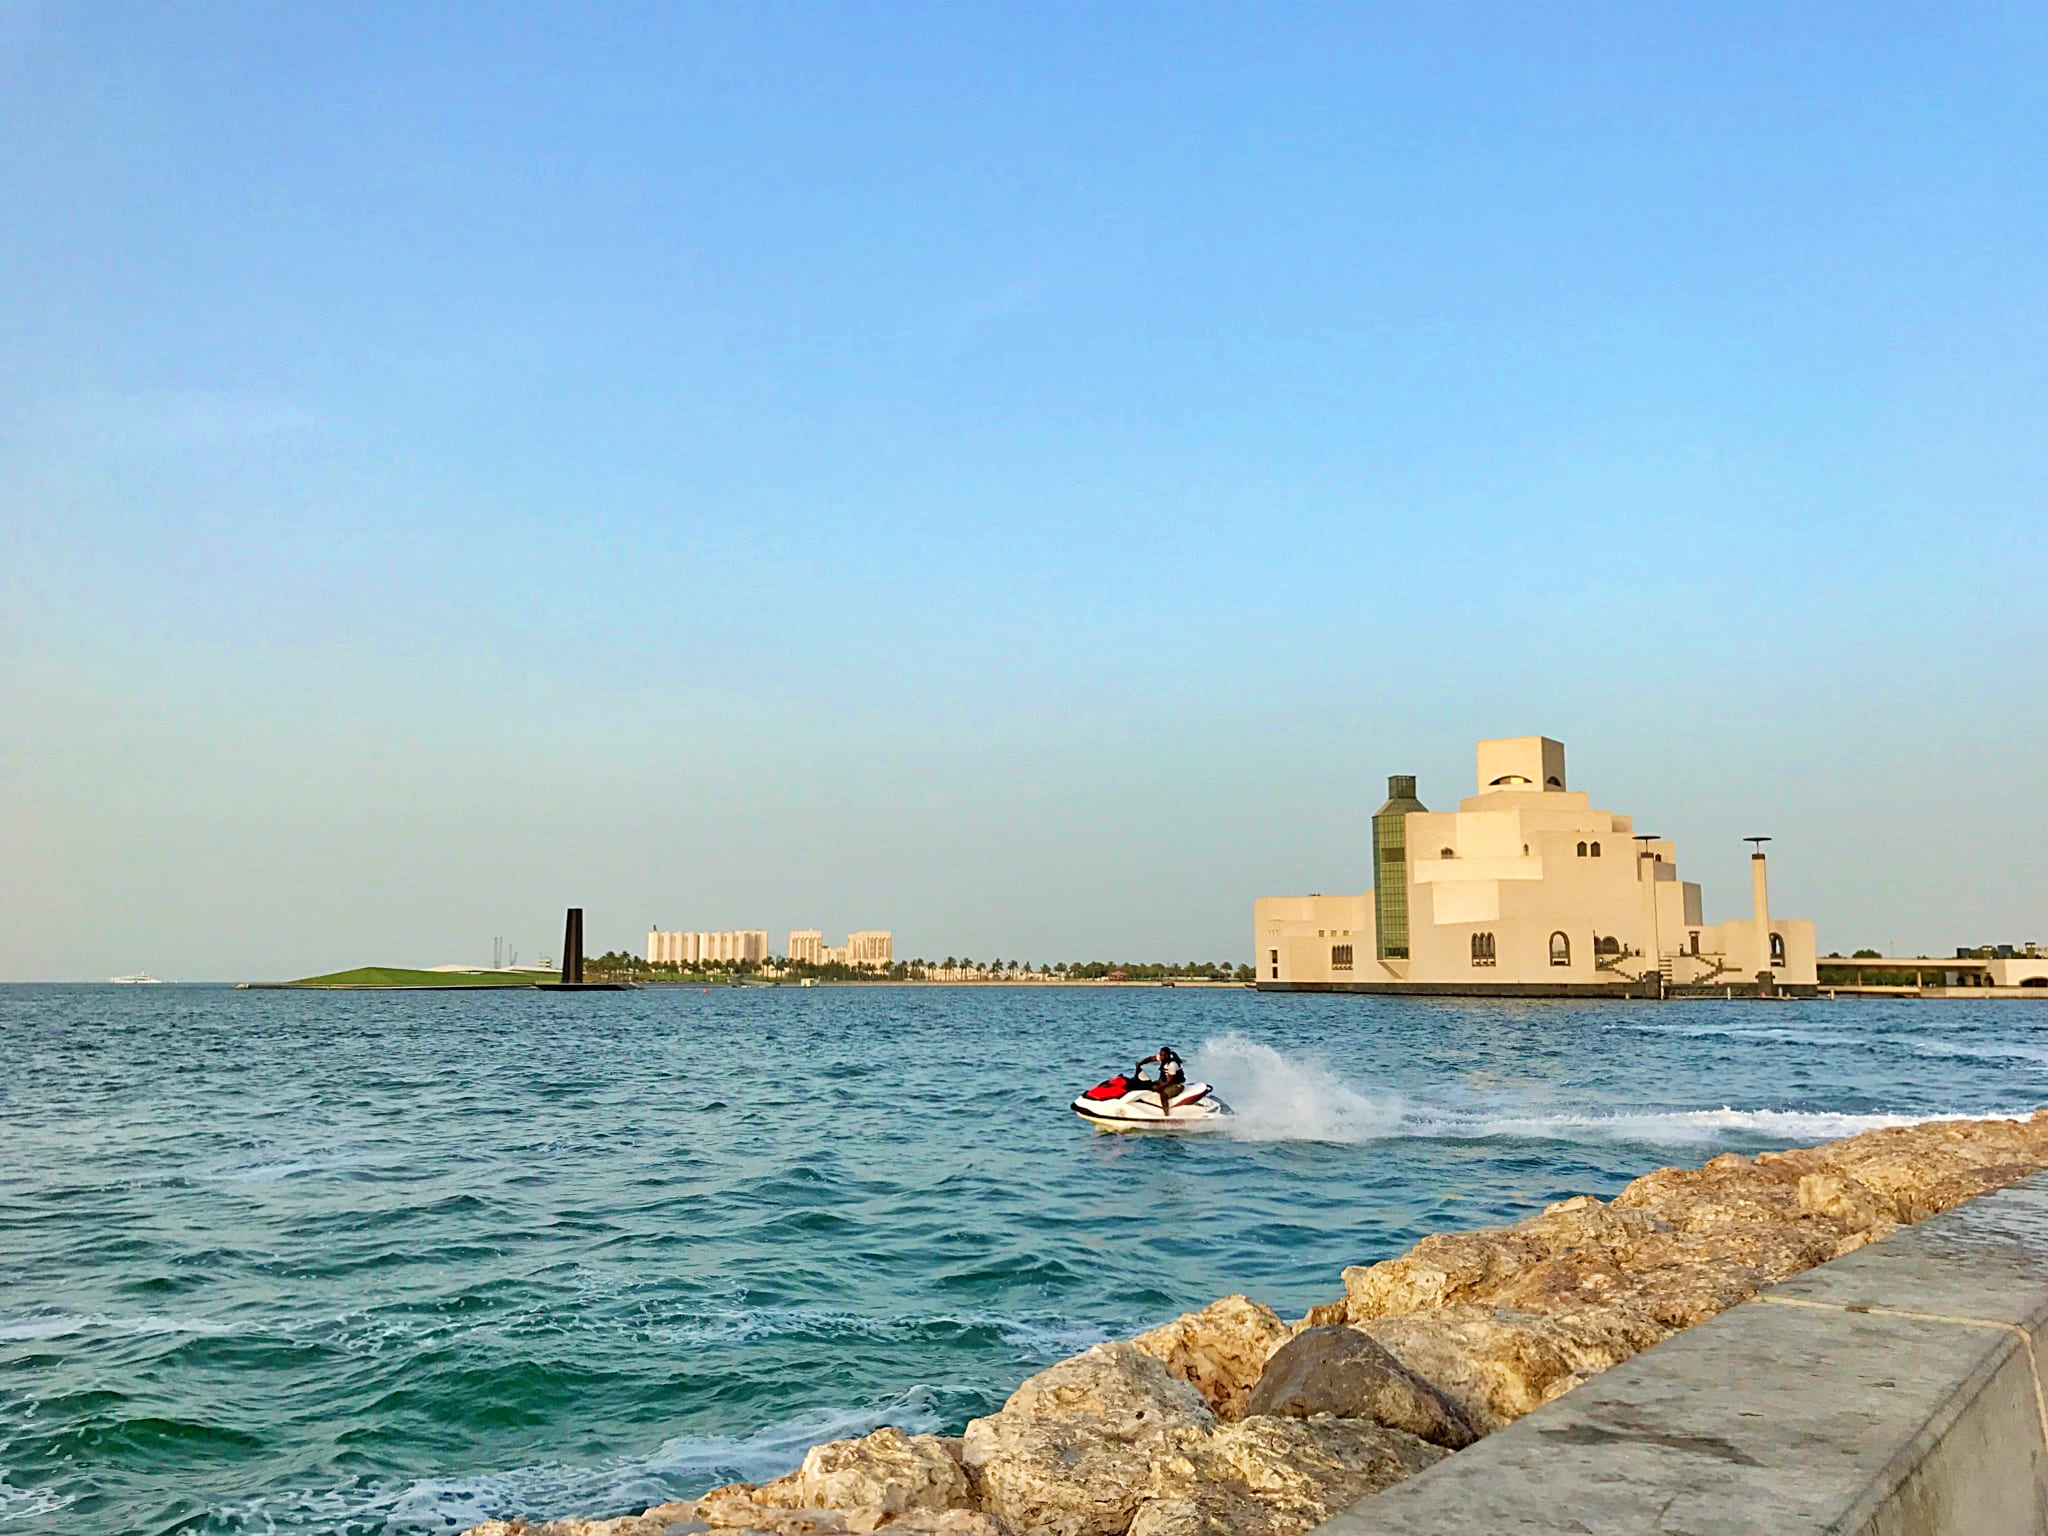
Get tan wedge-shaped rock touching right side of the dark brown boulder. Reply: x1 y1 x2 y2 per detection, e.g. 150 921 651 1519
1360 1305 1663 1434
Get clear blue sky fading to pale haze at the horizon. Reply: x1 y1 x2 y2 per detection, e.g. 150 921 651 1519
0 0 2048 979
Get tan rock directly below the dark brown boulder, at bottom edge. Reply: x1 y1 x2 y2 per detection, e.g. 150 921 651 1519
1130 1415 1446 1536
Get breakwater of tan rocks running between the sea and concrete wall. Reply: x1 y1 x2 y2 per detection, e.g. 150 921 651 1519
467 1110 2048 1536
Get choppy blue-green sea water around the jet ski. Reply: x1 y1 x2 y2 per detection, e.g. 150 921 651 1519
0 987 2048 1536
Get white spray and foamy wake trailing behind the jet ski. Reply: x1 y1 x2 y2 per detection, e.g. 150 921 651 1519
1192 1034 1964 1147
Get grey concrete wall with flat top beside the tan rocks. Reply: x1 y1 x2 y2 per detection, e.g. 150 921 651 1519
1317 1174 2048 1536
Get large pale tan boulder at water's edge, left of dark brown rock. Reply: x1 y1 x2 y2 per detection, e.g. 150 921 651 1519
961 1341 1217 1536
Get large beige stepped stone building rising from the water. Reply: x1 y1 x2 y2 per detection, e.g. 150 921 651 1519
1251 735 1815 997
